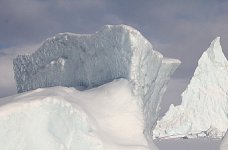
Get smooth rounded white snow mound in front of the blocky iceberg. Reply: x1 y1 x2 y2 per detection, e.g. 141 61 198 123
0 79 157 150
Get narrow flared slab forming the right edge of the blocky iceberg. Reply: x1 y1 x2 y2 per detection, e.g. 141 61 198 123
143 58 180 138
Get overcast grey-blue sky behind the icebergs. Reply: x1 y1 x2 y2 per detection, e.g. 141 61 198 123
0 0 228 149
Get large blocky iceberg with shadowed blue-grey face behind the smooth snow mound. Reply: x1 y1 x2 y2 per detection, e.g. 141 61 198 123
13 25 180 137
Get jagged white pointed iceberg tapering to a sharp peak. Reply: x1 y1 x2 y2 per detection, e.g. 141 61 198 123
153 37 228 138
